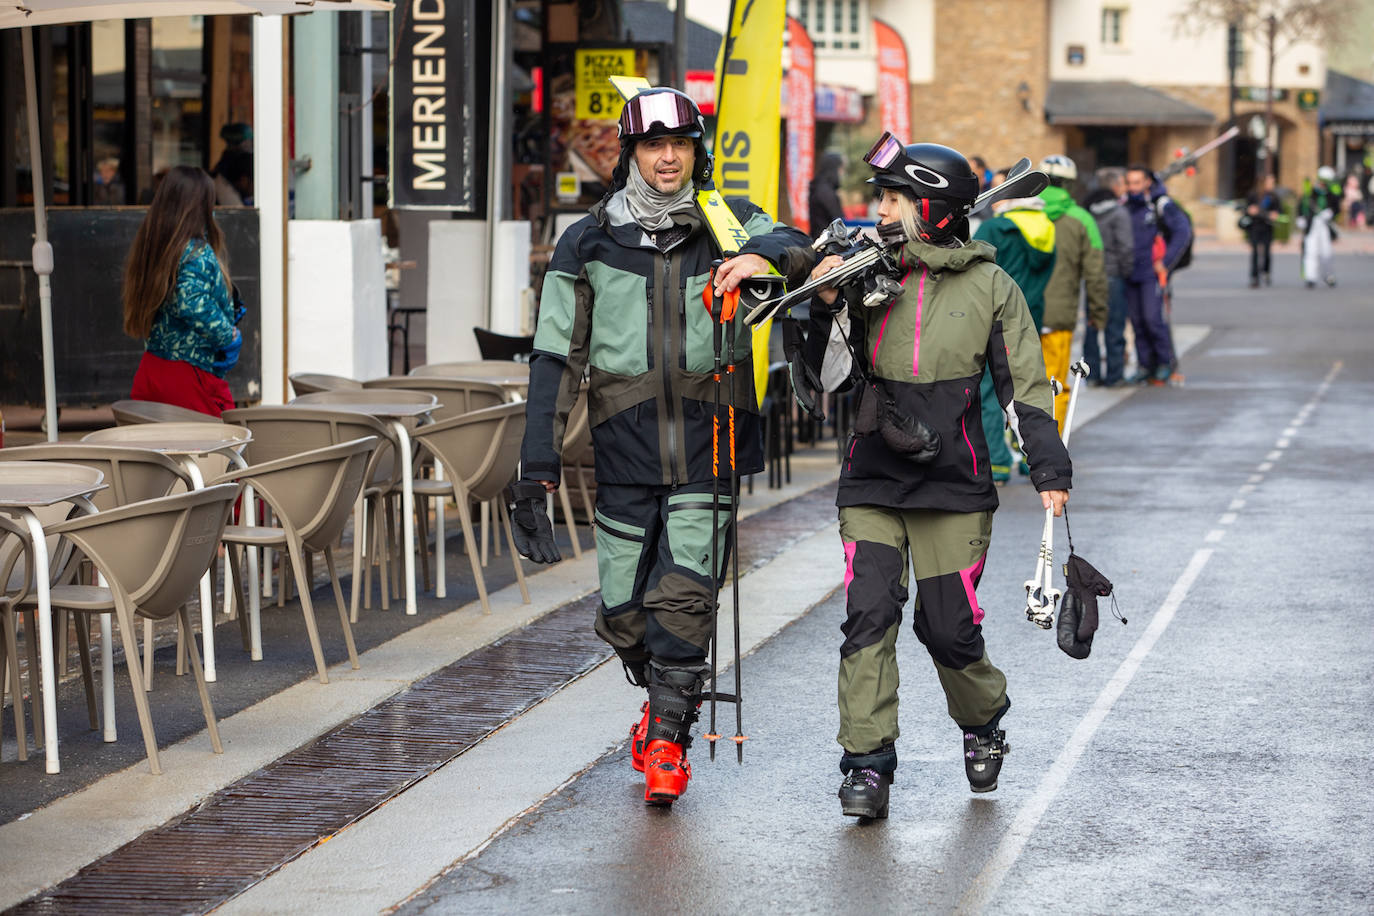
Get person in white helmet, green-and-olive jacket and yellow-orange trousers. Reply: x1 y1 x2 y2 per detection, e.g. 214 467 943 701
1040 155 1107 433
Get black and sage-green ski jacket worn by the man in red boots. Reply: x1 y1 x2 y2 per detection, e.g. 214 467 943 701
521 192 816 486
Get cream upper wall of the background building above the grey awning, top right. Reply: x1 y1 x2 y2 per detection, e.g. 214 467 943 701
1050 0 1326 88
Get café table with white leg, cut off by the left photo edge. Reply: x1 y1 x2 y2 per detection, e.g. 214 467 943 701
0 461 107 773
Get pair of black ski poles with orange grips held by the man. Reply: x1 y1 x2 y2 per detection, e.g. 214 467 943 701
702 261 747 764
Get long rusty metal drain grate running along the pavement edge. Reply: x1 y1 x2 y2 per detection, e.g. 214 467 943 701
5 486 834 916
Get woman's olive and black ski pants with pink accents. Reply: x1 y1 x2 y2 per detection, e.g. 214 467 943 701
838 505 1007 773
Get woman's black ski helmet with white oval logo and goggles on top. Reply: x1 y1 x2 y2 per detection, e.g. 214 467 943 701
863 132 978 242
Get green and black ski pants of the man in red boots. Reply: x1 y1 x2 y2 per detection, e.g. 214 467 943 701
596 481 731 687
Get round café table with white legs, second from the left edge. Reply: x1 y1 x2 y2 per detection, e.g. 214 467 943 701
81 419 262 681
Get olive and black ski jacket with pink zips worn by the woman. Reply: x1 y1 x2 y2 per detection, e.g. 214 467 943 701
808 234 1073 512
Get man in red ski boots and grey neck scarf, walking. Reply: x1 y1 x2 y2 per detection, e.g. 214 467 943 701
513 88 815 805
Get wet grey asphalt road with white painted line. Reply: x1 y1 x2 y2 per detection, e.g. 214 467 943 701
403 254 1374 913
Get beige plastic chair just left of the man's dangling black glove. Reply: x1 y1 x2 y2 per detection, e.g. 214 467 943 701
415 402 529 614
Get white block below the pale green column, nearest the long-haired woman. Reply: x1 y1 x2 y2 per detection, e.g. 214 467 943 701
286 220 386 379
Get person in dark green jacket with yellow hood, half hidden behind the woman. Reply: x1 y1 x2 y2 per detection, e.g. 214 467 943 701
973 198 1055 483
